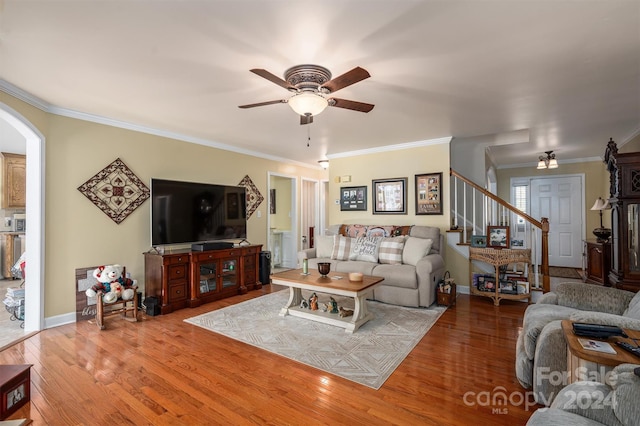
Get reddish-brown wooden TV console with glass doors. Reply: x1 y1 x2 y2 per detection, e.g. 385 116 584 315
144 244 262 315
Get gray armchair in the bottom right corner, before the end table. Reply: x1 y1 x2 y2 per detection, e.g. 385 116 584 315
527 364 640 426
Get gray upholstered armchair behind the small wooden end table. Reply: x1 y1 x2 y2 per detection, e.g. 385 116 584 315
516 282 640 406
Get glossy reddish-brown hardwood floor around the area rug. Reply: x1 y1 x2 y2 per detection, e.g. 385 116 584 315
0 285 537 426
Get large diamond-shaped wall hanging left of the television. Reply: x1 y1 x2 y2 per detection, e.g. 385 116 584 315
78 158 149 224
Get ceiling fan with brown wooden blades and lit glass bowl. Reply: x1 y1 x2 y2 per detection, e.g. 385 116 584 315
238 64 374 124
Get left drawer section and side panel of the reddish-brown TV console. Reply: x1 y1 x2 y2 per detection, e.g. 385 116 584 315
144 252 189 315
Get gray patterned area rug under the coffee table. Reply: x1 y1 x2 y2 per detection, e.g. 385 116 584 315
185 290 446 389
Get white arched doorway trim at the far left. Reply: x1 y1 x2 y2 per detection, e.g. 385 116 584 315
0 102 45 333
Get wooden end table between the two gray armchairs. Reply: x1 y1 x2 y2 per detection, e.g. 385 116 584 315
562 320 640 383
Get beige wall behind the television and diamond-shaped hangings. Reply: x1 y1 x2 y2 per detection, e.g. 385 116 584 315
0 92 325 318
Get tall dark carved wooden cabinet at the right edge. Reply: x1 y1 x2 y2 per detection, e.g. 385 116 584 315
605 140 640 291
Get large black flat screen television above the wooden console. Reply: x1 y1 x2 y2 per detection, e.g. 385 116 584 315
151 179 247 246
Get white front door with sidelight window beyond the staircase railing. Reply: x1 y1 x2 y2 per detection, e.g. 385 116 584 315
531 176 584 268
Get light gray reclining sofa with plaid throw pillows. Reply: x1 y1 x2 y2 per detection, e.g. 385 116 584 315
298 225 445 307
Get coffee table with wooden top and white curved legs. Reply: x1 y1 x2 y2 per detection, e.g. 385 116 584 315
271 269 384 333
